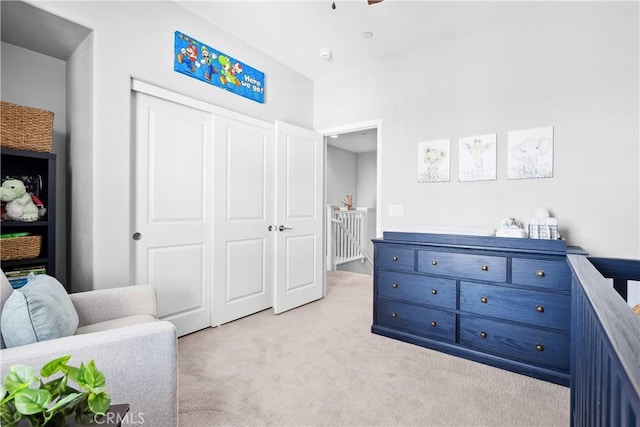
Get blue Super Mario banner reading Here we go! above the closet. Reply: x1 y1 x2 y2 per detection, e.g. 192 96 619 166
173 31 264 104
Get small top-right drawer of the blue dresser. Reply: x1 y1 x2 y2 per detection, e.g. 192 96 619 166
511 258 571 291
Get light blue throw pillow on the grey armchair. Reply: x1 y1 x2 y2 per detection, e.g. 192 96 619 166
0 274 78 348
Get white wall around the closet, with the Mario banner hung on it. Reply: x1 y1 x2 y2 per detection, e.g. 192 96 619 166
33 1 313 289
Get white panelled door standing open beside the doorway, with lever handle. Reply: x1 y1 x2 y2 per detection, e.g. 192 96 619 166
274 122 325 314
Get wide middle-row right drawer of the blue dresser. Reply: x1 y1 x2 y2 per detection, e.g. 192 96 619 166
460 282 571 331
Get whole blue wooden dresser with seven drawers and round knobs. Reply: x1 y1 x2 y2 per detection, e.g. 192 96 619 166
371 232 584 386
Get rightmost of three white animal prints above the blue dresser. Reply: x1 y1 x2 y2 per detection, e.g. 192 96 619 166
507 126 553 179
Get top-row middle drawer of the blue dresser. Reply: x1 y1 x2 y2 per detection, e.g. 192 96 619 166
418 251 507 282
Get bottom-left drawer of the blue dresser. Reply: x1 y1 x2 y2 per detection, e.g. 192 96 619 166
376 298 456 342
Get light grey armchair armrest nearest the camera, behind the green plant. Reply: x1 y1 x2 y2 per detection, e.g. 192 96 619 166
0 321 178 426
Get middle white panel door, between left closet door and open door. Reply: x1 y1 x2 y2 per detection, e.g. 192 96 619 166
211 115 275 326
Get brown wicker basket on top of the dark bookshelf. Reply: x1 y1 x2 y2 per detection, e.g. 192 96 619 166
0 101 53 153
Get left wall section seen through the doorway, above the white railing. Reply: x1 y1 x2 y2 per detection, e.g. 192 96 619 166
326 145 359 207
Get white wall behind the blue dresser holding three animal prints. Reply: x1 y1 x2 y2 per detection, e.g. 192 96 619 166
314 2 640 258
